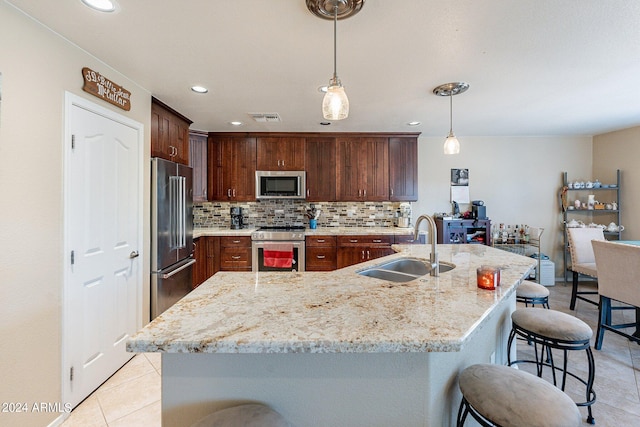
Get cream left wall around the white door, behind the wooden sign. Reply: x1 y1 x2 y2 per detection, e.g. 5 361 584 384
0 2 151 426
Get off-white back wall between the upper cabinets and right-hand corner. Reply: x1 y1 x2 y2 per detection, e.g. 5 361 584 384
412 136 592 277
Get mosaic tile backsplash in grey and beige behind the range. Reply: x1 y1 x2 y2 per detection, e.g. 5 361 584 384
193 200 410 228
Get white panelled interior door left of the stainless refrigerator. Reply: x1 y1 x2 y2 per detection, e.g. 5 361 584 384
63 94 143 407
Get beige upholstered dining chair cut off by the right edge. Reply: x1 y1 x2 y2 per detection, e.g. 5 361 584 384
593 240 640 350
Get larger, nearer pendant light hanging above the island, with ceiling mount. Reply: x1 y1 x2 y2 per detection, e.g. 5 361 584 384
307 0 364 120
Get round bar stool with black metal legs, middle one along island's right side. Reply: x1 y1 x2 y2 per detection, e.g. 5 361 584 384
507 307 596 424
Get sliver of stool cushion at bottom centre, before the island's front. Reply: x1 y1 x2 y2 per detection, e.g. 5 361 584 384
191 403 289 427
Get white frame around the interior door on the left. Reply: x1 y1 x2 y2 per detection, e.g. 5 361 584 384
60 91 144 408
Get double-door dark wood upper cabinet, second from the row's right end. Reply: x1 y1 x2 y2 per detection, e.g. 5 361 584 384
337 136 389 201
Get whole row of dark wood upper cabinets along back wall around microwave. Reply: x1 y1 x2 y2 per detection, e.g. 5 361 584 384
202 132 418 202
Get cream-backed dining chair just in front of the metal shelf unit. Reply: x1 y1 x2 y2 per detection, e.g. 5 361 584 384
567 227 605 310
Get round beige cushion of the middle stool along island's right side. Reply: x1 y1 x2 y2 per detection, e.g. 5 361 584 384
511 307 593 341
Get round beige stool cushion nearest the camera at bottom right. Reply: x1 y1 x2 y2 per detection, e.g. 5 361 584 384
460 364 582 427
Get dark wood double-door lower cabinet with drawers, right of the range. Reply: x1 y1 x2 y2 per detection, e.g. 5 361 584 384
337 235 395 268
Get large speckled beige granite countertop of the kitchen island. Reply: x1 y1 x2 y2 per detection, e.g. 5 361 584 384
127 245 537 353
